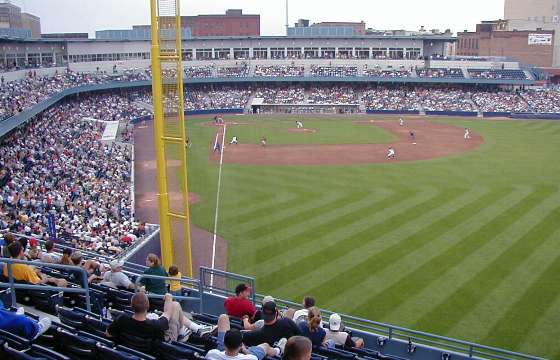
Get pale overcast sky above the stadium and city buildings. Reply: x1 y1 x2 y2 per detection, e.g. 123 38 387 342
12 0 504 36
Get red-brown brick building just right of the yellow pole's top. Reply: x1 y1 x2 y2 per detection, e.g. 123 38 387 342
181 9 261 37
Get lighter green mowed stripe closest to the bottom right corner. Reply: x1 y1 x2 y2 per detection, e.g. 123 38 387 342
444 231 560 346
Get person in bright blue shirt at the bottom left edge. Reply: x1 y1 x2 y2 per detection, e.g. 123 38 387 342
0 301 51 341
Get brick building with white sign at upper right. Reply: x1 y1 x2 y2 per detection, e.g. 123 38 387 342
457 20 555 67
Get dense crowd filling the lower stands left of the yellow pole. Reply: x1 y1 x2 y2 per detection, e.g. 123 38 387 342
0 94 145 253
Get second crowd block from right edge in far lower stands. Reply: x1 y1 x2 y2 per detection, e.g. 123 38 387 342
472 91 529 112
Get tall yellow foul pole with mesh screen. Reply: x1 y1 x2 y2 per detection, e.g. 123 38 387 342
150 0 192 276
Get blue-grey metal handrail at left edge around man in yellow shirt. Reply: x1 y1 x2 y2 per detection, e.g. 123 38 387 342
0 258 91 311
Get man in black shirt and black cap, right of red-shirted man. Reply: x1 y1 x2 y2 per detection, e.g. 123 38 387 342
243 301 301 346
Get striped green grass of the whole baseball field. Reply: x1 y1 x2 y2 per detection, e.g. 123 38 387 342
184 117 560 358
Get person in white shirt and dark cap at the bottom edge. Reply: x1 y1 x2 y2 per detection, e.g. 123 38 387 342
206 314 285 360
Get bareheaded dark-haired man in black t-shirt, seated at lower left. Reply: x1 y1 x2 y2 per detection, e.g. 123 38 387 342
106 292 173 354
